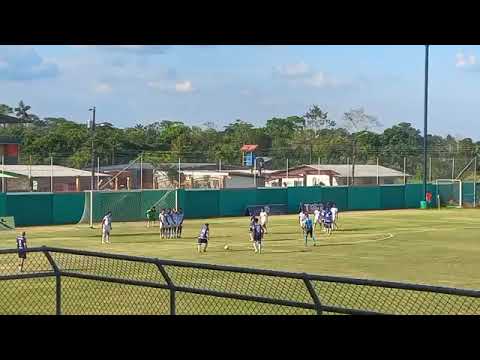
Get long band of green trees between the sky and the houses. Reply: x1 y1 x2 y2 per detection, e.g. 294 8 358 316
0 101 480 178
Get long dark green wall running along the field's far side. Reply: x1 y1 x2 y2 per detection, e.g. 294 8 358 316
0 182 480 226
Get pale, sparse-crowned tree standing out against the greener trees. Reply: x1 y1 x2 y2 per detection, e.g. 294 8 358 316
343 108 381 185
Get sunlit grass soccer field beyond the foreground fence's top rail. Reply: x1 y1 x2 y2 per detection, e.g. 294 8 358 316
0 209 480 289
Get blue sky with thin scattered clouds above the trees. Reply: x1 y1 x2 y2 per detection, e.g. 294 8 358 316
0 45 480 140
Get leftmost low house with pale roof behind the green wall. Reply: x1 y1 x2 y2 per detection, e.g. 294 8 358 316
0 165 109 192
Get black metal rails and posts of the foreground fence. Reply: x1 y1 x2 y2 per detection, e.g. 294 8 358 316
0 246 480 315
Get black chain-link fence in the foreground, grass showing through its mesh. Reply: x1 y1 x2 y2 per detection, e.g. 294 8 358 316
0 247 480 315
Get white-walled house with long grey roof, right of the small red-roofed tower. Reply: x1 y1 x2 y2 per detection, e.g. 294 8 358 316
266 164 410 187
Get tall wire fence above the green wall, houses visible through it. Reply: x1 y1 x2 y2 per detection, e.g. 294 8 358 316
0 151 479 192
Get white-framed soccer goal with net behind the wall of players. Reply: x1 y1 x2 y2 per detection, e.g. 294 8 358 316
79 189 178 226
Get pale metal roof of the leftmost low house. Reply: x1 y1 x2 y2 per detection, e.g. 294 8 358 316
0 165 111 177
